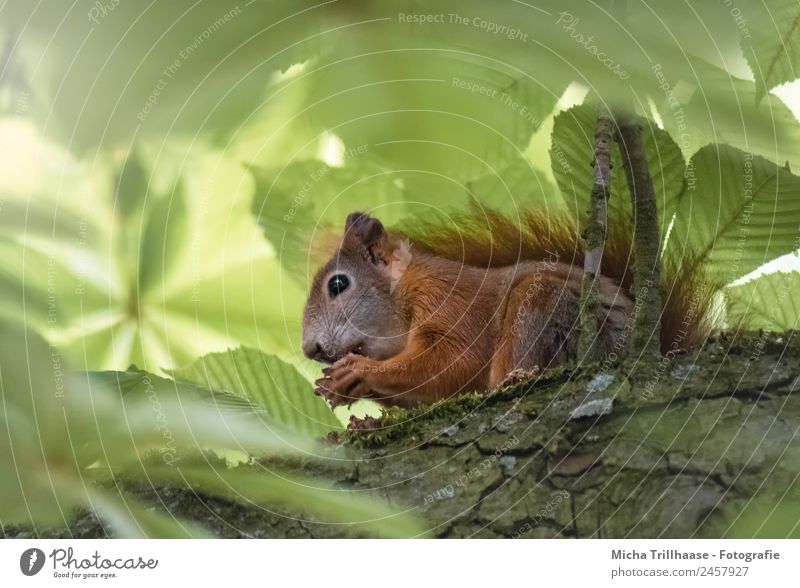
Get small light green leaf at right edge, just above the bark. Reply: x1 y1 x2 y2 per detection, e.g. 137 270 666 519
726 271 800 331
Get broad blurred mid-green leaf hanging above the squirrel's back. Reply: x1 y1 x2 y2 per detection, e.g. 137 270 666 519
308 49 566 180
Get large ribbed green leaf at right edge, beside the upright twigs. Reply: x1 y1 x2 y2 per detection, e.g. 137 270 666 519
664 145 800 283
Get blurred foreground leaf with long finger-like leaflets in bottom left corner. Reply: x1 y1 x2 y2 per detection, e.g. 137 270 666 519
0 323 424 537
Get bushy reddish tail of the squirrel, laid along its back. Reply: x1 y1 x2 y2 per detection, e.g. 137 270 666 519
397 208 722 353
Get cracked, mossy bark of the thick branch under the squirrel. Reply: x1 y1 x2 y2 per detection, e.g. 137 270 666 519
7 333 800 538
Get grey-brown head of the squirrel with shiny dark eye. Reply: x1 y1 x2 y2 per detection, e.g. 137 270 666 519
303 212 405 363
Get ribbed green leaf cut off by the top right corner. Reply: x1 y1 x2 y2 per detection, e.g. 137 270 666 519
738 0 800 101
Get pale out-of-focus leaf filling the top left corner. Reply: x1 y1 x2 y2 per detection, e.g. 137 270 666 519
2 0 325 150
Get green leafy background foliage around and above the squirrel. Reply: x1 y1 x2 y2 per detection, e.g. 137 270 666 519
0 0 800 535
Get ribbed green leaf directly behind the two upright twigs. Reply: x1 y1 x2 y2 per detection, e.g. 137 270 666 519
550 103 686 240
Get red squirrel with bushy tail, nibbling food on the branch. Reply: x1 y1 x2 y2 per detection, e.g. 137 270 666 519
302 210 713 408
